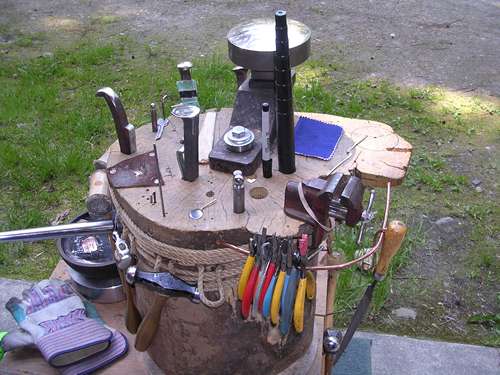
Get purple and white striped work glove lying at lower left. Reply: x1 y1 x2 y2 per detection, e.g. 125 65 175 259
2 280 113 367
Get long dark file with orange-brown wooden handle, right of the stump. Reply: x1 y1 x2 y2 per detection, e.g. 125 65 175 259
325 220 407 368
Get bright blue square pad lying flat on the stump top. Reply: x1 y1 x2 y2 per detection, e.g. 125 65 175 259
295 116 344 160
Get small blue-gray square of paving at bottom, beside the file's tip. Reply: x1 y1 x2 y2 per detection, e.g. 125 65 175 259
334 337 372 375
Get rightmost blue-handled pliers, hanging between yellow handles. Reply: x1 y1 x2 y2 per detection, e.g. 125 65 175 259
279 239 300 336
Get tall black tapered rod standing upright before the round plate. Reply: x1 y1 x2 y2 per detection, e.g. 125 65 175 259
274 10 295 174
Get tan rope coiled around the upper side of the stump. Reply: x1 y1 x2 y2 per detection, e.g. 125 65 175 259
111 192 245 308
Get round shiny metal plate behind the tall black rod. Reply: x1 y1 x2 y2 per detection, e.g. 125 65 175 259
227 18 311 71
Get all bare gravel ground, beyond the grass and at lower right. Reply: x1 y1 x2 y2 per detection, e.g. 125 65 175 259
0 0 500 346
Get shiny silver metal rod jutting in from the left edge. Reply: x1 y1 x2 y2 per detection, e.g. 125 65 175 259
0 220 113 243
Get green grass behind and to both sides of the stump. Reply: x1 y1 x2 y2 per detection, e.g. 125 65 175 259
0 33 500 344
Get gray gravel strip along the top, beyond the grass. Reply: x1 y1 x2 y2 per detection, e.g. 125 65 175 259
0 0 500 96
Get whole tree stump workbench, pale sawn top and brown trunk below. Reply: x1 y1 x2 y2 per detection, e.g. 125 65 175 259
0 109 412 375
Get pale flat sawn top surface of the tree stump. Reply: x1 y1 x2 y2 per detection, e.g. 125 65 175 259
108 109 411 249
